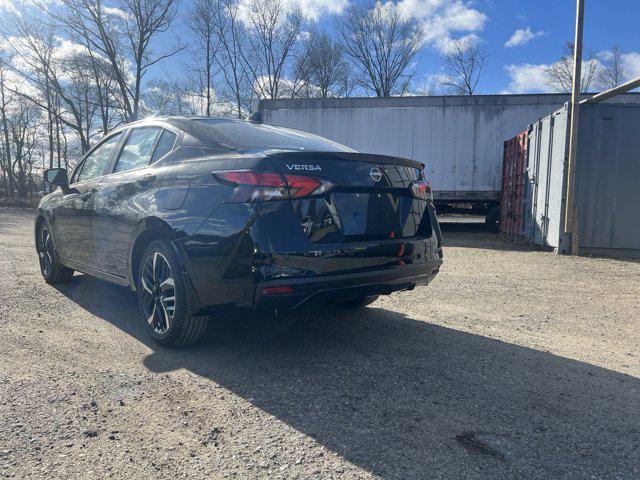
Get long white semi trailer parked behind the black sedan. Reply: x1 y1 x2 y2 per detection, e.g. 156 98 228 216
258 94 639 227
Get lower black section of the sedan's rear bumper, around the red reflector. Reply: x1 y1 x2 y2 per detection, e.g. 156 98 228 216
253 260 442 310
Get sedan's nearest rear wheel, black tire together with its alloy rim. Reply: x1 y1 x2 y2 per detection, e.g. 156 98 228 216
136 239 207 347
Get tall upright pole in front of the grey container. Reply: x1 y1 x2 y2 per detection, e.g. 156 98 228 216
564 0 584 255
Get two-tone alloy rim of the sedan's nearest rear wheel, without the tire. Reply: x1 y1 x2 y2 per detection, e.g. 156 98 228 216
140 252 176 334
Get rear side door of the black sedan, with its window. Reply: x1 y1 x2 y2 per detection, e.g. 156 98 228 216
91 126 177 278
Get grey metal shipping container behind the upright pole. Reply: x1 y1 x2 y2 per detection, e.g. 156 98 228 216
523 104 640 256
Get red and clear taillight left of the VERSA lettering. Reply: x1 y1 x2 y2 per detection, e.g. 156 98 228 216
213 170 333 202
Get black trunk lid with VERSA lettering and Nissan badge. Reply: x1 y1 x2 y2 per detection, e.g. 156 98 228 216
269 151 431 242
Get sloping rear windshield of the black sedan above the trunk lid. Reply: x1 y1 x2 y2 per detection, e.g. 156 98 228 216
193 118 355 152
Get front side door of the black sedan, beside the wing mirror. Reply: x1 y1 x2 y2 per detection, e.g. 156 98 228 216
53 133 121 266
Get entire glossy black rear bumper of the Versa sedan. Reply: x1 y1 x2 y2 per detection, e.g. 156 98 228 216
174 202 442 313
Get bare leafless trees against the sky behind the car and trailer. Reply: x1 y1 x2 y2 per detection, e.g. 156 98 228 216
0 0 632 201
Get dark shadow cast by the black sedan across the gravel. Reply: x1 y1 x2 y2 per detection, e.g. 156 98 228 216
53 276 640 479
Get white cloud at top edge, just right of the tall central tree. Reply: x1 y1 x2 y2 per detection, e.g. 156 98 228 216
397 0 488 53
